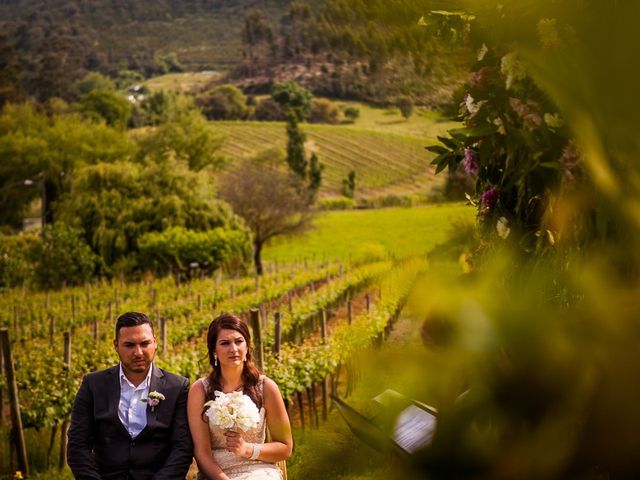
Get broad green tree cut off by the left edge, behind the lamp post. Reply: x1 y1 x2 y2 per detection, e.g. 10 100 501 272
0 104 135 227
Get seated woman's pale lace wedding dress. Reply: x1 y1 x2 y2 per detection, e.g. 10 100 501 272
198 376 282 480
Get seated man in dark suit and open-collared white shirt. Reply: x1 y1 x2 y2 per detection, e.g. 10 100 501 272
67 312 193 480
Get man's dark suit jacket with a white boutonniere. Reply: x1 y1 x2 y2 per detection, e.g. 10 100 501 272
67 365 193 480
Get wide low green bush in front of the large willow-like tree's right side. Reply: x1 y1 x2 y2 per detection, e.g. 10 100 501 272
138 227 251 272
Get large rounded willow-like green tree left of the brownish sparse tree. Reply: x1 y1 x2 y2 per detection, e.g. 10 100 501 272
56 157 244 272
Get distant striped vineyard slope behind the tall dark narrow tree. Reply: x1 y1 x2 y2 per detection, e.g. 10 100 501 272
215 122 442 197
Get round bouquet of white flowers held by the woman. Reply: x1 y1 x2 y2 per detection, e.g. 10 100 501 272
204 390 260 432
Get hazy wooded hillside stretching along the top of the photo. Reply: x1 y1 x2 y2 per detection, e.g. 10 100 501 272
0 0 473 107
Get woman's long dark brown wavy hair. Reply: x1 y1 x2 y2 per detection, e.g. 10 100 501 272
206 313 262 408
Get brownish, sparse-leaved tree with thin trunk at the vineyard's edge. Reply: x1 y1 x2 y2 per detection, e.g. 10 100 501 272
219 150 312 275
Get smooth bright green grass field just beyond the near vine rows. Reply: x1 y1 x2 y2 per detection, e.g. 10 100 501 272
264 203 475 261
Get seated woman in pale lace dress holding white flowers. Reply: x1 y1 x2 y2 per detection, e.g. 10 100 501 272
187 313 293 480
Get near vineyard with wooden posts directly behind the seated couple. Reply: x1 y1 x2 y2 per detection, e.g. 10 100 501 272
0 253 425 474
